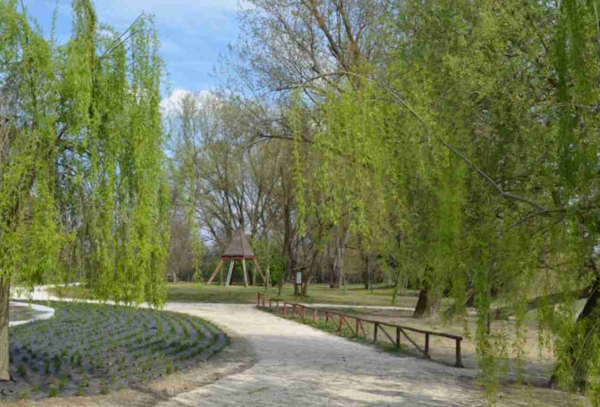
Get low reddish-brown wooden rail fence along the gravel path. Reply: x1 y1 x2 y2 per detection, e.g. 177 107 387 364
256 293 464 367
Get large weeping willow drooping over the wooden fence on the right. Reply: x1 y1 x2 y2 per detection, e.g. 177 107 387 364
288 0 600 405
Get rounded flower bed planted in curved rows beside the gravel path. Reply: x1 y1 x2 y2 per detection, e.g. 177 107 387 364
0 303 228 400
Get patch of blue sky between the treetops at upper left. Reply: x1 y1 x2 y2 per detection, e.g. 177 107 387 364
24 0 238 102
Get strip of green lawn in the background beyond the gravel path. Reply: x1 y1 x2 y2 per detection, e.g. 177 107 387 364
52 283 417 307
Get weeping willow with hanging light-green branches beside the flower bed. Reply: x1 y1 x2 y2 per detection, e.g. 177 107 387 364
0 0 169 380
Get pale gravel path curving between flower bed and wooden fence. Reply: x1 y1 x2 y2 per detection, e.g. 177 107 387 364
159 304 484 407
